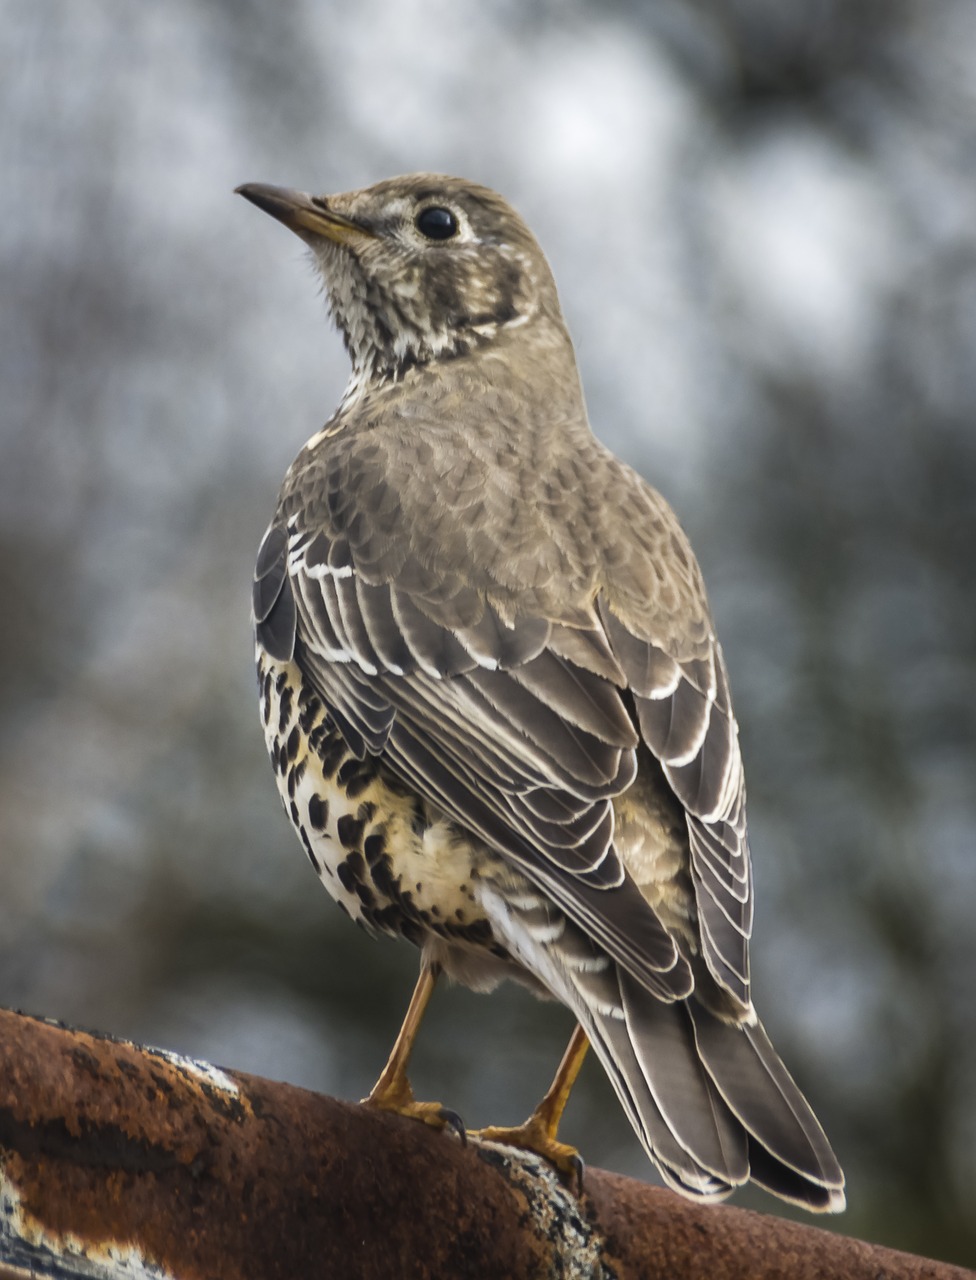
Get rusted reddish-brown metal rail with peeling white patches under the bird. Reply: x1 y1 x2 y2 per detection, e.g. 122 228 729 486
0 1010 972 1280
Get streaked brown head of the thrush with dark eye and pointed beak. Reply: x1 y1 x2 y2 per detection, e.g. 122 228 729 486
237 174 569 383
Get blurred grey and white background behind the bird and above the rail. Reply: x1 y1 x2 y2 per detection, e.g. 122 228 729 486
0 0 976 1266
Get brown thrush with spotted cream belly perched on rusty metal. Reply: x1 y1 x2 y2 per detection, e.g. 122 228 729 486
238 174 844 1211
